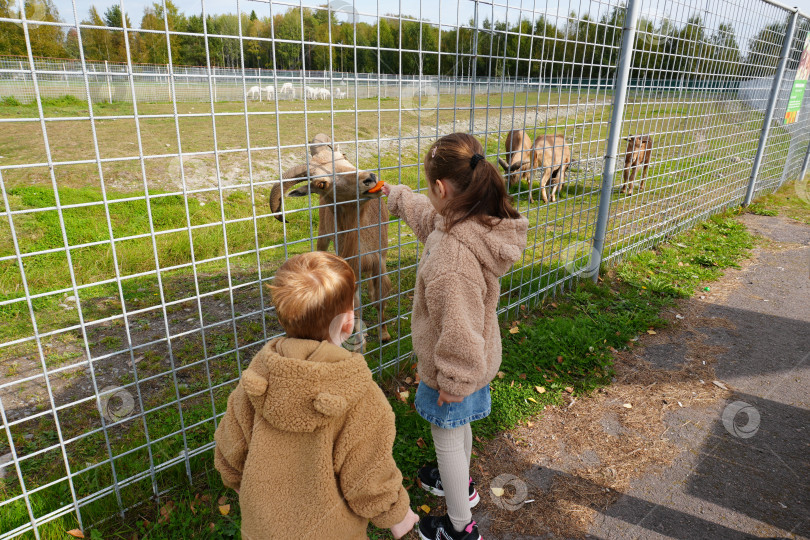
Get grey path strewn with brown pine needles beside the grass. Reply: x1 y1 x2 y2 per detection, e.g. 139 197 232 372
472 215 810 540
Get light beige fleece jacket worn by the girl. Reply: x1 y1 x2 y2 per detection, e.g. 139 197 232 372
388 186 529 396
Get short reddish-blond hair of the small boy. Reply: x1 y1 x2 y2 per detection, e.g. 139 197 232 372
270 251 355 340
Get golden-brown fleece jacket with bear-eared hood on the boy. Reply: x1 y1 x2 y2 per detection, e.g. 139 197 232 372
214 338 410 540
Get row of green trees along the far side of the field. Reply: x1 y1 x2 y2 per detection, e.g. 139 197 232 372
0 0 799 80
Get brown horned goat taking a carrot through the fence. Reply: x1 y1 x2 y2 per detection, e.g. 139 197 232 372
270 133 391 341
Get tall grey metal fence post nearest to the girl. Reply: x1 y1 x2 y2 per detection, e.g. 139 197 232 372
586 0 641 281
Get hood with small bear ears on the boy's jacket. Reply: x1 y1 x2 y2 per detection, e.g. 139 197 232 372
239 338 373 432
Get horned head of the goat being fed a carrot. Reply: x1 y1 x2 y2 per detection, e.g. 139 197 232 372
270 133 382 221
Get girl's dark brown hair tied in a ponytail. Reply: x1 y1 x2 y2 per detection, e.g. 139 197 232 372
425 133 520 231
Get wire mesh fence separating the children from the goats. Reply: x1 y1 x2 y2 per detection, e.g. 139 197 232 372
0 0 810 539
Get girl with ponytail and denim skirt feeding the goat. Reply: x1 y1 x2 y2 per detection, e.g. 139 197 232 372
382 133 529 540
